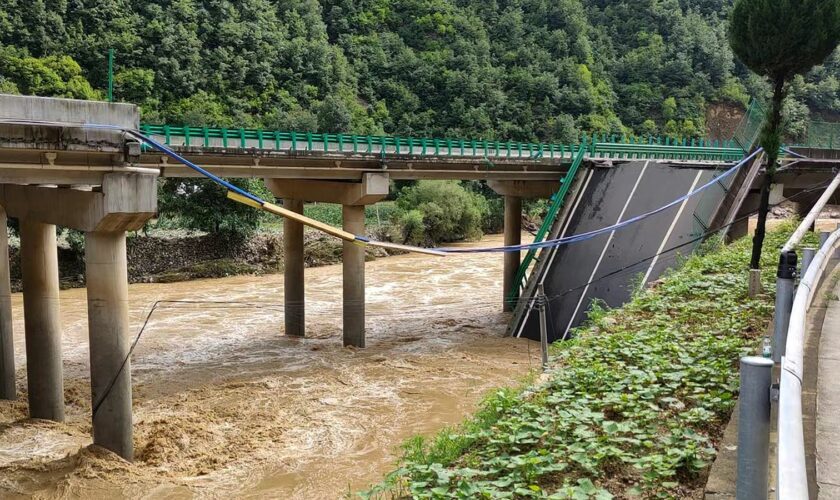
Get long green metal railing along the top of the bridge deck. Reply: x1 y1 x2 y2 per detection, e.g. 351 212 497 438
140 124 743 161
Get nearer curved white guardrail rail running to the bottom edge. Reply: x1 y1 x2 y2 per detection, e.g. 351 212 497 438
777 230 840 500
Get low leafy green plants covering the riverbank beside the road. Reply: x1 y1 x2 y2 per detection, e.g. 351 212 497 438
360 224 816 499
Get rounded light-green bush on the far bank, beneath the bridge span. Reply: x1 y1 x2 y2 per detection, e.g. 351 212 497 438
397 180 490 245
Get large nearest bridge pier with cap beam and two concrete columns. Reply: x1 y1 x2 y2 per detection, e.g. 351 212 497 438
0 173 157 460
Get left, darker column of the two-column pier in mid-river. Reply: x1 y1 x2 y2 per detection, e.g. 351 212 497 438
283 199 306 337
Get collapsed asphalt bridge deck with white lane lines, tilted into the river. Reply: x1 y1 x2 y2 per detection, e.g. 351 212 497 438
508 160 734 341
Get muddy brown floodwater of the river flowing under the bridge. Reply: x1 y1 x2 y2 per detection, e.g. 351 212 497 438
0 236 539 499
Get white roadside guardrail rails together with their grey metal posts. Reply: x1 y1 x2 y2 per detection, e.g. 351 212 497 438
736 170 840 500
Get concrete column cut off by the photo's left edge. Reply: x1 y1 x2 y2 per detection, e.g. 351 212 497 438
0 207 17 399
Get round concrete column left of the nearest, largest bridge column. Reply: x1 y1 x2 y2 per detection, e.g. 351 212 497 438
20 219 64 422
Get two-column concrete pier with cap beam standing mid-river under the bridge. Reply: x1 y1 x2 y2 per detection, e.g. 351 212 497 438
266 173 389 347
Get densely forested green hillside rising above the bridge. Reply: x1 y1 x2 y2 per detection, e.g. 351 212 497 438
0 0 840 141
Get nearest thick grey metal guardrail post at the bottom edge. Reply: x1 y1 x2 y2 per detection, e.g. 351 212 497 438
736 356 773 500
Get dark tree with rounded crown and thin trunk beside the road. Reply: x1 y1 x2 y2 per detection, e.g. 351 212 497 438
729 0 840 269
